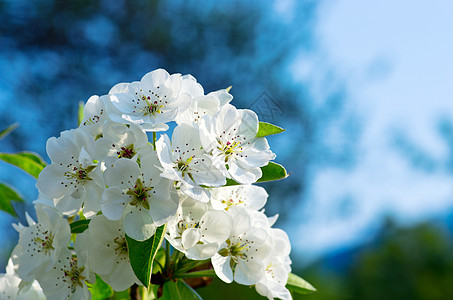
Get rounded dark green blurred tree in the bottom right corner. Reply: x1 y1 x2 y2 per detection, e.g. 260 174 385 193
349 220 453 300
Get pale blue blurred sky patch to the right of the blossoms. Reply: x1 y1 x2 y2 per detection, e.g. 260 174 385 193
282 0 453 260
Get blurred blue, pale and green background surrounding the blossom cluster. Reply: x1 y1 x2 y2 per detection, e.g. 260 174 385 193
0 0 453 300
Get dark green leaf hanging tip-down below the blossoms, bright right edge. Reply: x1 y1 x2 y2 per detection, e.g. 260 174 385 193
126 224 167 287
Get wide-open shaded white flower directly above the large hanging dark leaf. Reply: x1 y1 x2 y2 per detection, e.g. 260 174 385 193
101 151 178 240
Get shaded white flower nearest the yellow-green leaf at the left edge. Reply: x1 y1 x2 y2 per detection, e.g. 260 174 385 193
36 130 104 216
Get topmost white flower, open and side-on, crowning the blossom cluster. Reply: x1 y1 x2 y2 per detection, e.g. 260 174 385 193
109 69 191 131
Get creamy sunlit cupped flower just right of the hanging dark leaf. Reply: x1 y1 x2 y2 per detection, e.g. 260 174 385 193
166 196 231 260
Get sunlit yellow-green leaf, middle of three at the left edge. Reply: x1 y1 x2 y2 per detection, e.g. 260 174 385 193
0 152 46 179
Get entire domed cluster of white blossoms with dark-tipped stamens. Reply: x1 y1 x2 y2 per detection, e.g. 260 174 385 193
4 69 291 300
